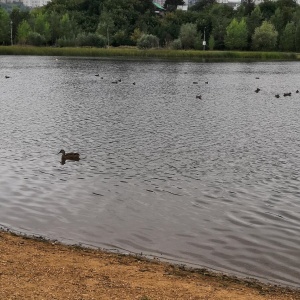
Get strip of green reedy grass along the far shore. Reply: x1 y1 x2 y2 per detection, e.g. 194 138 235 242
0 46 300 61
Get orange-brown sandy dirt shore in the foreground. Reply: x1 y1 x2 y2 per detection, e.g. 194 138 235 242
0 231 300 300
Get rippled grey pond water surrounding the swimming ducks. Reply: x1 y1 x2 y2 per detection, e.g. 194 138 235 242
0 56 300 286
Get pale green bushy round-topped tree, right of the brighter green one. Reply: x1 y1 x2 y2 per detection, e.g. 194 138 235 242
252 21 278 51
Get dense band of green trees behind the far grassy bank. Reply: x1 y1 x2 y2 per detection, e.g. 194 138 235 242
0 0 300 52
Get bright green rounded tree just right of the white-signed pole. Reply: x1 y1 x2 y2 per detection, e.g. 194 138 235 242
224 18 248 50
